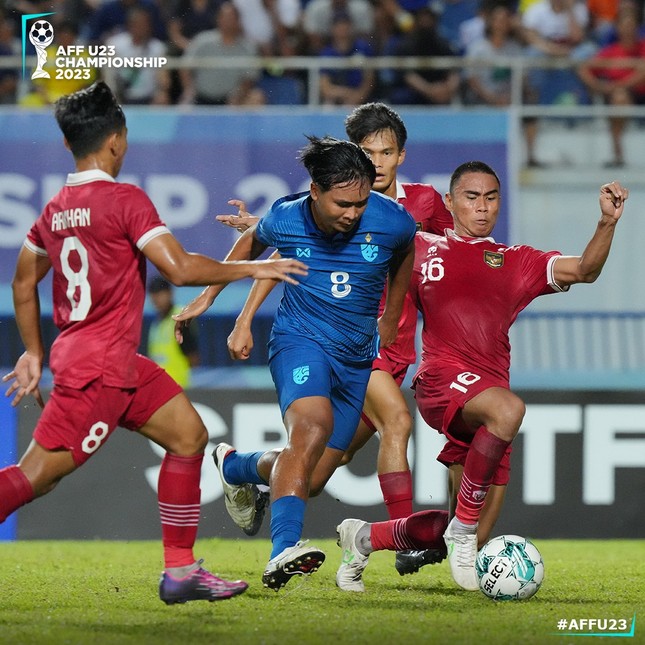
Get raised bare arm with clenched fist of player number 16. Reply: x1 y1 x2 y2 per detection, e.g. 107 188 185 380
553 181 629 286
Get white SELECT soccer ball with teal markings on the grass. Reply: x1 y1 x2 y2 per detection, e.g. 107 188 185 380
475 535 544 600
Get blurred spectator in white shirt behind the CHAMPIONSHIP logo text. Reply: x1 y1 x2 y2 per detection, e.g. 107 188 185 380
103 6 169 105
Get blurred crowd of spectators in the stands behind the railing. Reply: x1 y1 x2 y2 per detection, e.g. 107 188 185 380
0 0 645 166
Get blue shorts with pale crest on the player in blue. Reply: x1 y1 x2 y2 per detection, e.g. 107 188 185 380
269 336 372 451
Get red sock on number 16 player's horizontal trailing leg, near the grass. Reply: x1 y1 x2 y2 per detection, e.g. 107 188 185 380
370 511 448 551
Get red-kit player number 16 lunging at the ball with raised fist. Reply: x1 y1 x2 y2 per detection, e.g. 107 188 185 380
337 161 628 590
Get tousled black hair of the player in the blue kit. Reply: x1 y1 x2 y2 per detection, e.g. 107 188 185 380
300 136 376 192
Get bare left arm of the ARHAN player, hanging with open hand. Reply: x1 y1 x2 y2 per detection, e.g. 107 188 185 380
2 246 51 407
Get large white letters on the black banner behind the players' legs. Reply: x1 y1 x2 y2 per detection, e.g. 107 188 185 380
141 403 645 507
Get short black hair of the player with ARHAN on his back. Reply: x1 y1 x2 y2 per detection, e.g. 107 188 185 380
54 81 125 159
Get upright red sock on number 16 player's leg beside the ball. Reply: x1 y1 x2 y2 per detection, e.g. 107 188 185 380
455 426 510 524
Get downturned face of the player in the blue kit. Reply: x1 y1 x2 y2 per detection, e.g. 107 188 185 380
311 181 370 234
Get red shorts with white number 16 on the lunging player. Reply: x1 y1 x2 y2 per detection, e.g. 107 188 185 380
412 365 511 486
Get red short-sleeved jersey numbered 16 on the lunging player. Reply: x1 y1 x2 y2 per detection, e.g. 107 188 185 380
410 231 565 382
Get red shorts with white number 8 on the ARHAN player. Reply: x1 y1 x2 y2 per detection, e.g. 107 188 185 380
34 355 182 466
